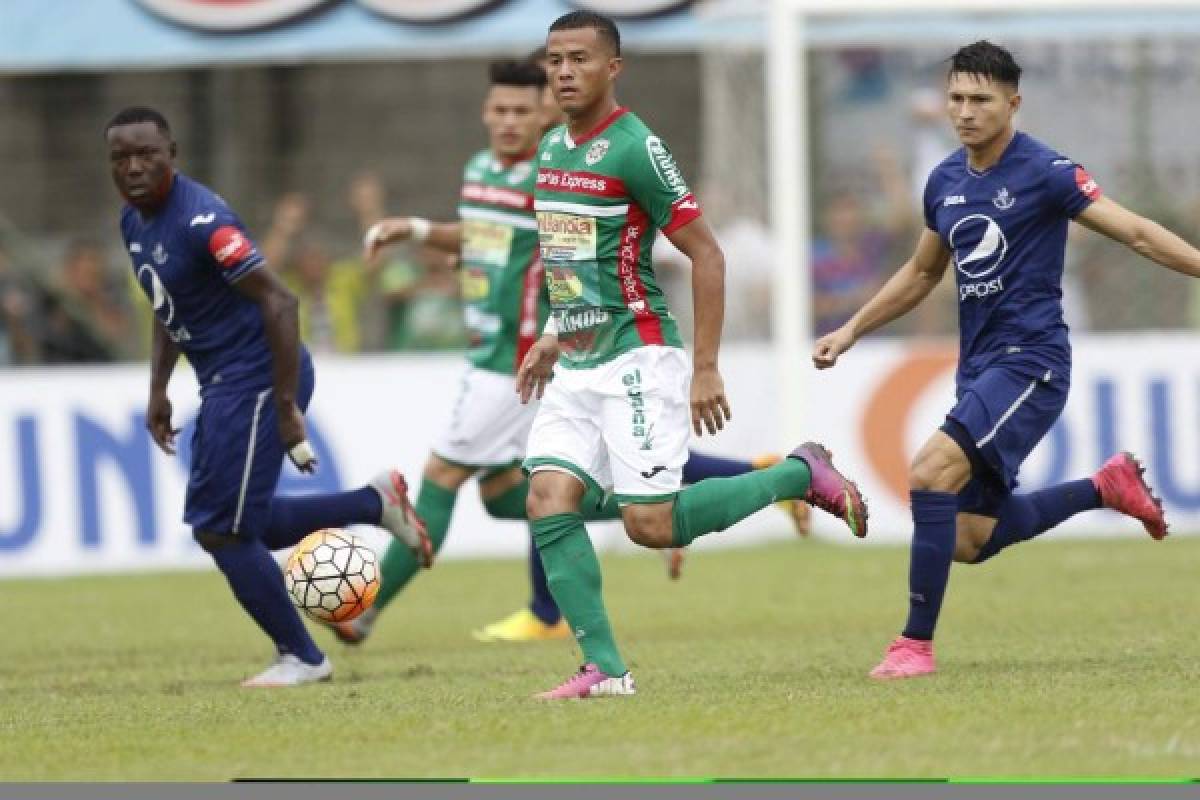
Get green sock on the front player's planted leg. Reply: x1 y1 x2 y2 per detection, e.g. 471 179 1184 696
529 513 628 678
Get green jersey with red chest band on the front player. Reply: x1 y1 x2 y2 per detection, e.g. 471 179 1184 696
534 108 701 368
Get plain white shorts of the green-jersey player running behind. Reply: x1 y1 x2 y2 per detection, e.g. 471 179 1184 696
433 367 538 467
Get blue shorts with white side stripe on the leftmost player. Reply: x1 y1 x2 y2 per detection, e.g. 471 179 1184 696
184 356 314 539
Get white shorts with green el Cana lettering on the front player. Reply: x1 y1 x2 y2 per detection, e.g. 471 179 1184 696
524 345 691 505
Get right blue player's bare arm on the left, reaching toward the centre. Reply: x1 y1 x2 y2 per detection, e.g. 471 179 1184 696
812 228 950 369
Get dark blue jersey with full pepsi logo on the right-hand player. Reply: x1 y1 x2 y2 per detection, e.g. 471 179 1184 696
924 132 1100 383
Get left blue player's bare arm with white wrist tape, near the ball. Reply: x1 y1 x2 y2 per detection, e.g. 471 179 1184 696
233 270 317 473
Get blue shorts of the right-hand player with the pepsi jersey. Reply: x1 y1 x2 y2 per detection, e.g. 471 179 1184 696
942 365 1070 516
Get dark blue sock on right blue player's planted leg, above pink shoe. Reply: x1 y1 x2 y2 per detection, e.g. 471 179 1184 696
904 489 959 640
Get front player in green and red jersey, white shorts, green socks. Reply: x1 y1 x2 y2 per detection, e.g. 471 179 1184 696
517 11 866 699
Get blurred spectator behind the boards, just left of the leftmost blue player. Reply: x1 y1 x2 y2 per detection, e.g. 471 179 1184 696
41 240 134 363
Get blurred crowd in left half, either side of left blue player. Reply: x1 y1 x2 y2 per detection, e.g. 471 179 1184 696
0 174 467 366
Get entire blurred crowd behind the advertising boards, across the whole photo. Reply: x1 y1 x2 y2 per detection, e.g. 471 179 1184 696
7 131 1200 367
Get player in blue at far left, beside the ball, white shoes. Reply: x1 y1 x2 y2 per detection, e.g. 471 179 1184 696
104 107 433 687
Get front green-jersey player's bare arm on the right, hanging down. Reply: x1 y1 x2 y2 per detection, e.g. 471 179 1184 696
667 217 731 437
